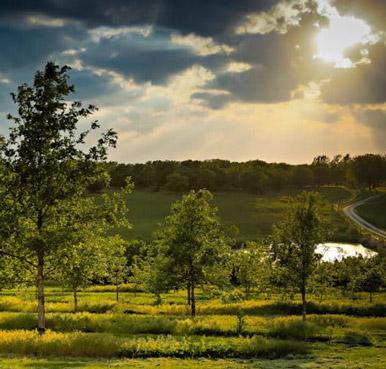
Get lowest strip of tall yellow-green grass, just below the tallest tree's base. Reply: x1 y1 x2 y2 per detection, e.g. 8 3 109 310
0 331 309 359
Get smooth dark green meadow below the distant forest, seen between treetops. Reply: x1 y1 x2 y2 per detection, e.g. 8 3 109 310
119 187 358 242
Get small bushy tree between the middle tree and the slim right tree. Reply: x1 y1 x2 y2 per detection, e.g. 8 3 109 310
233 242 269 298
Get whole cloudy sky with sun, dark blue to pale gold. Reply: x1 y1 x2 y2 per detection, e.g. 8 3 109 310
0 0 386 163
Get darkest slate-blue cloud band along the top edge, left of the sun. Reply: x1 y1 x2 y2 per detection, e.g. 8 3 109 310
1 0 278 36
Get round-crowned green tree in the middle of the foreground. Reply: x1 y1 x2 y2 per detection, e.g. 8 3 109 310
156 190 230 316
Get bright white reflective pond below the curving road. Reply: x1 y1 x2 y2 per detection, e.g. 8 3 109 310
316 242 377 262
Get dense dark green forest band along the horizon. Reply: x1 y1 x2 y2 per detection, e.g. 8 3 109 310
98 154 386 193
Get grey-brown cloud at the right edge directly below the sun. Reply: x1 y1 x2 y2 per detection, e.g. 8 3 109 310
322 44 386 105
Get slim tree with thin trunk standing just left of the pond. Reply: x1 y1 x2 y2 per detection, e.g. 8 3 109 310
270 192 324 321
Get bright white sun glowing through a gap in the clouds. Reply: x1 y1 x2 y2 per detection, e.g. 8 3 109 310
315 3 377 68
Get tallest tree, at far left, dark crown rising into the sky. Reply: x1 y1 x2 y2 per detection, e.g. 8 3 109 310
0 62 117 334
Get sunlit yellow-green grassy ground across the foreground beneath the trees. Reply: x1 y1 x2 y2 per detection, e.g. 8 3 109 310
0 285 386 369
